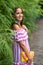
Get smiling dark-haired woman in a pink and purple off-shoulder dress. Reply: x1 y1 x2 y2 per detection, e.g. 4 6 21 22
12 7 34 65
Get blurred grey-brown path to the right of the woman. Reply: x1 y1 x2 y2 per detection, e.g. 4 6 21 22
30 19 43 65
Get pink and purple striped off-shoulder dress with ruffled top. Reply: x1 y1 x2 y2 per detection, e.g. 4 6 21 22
12 29 33 65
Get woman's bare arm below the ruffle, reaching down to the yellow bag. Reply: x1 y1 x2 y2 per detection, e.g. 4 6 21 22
18 41 34 62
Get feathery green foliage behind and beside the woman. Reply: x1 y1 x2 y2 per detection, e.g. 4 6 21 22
0 0 43 65
